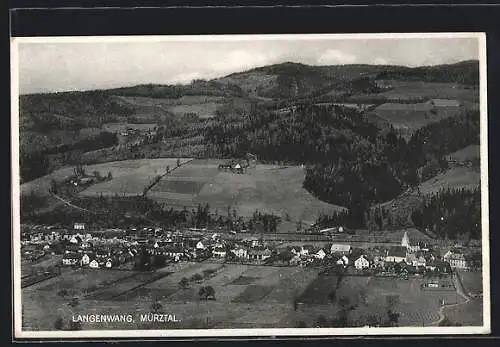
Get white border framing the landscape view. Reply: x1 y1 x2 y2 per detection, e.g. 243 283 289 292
11 32 491 339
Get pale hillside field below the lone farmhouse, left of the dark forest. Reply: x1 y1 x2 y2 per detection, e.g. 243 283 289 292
148 160 341 223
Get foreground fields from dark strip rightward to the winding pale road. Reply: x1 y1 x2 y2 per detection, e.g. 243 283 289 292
288 275 466 326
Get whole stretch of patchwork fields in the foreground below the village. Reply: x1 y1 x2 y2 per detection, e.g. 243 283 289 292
23 262 480 330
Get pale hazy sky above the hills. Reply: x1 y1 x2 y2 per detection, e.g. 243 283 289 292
18 36 479 94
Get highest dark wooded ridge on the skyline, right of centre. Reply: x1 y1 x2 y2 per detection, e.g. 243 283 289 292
214 60 479 99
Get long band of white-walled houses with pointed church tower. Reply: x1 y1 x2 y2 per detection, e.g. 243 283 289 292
22 223 481 272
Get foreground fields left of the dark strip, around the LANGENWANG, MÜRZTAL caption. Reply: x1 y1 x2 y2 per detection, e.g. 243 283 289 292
23 263 316 330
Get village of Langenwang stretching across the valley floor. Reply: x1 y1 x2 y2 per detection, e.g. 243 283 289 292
21 223 481 277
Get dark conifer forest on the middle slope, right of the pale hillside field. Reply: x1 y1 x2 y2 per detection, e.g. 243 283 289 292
206 105 479 226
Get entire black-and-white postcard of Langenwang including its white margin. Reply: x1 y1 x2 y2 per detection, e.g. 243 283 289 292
11 33 490 338
